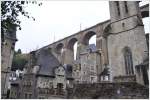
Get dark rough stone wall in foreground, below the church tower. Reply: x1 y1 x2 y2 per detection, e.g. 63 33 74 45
67 82 149 99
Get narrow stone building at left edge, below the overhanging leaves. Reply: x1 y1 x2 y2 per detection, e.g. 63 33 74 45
1 30 17 98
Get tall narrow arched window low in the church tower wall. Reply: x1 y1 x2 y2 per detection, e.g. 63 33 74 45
124 47 134 75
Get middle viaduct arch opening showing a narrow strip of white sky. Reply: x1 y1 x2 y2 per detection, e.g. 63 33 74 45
67 38 78 60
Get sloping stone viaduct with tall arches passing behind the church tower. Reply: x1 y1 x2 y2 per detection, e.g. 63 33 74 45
37 4 149 73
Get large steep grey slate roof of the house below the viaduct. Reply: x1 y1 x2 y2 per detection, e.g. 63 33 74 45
37 49 60 77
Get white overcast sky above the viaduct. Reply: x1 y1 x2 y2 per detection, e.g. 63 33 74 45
15 1 150 53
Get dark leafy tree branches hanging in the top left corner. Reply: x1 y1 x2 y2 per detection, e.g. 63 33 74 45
1 1 42 42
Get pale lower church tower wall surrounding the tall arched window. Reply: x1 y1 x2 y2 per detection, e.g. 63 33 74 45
108 26 147 83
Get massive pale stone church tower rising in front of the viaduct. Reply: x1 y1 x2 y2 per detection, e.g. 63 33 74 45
107 1 148 84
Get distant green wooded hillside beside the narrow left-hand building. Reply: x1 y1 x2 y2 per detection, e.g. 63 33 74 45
11 49 28 70
